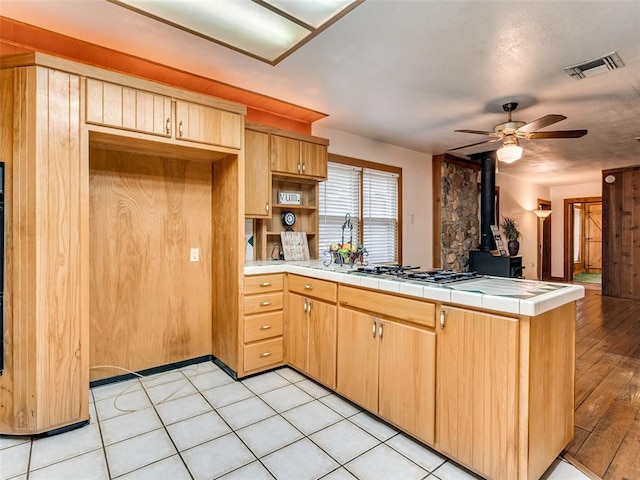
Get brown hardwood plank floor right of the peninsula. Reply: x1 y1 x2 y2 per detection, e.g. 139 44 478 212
564 286 640 480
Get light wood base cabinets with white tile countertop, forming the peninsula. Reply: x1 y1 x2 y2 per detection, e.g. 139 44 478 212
242 260 584 480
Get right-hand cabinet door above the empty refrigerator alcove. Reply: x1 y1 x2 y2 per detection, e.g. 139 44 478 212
176 100 243 149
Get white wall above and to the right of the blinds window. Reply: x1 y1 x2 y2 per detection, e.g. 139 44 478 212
313 124 433 267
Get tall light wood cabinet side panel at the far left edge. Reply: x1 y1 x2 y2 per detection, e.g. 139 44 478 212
0 62 89 435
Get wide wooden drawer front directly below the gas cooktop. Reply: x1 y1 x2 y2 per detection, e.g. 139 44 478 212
338 285 436 328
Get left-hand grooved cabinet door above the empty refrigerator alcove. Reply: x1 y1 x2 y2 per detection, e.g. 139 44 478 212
86 78 171 137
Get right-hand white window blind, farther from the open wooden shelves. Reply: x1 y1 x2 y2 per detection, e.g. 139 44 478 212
362 168 398 263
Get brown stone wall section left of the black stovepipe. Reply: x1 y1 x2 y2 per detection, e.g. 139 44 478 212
440 162 480 271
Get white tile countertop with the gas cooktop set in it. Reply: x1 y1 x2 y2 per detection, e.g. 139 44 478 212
244 260 584 317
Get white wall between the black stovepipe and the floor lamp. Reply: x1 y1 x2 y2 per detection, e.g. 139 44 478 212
496 172 555 279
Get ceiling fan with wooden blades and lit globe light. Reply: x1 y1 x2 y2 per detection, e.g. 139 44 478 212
449 102 587 163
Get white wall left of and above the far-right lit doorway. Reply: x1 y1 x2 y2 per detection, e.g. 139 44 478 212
550 182 602 277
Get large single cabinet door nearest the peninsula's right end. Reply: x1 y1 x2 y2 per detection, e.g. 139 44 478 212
436 307 518 478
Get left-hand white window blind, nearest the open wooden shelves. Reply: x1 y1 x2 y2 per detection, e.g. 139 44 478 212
318 162 362 253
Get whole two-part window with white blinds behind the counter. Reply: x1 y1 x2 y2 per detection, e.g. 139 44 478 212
319 162 399 263
